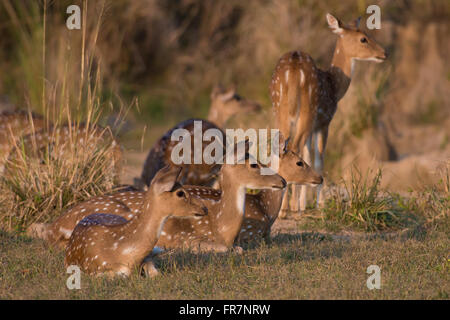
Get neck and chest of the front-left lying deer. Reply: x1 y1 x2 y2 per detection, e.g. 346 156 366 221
116 198 168 261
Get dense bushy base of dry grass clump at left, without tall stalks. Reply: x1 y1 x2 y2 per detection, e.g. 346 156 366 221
0 126 116 231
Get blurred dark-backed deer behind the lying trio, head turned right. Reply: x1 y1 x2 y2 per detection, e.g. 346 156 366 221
135 87 260 188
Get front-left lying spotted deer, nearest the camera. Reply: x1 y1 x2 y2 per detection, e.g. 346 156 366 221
65 167 207 276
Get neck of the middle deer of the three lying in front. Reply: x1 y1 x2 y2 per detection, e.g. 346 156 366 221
211 174 246 246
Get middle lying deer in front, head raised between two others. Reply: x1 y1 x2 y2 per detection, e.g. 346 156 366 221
156 153 286 252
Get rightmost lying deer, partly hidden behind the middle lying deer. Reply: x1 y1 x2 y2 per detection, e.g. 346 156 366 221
236 140 323 244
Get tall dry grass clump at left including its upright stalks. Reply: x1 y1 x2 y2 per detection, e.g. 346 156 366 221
0 1 125 231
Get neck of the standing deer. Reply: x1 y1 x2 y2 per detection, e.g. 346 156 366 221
327 39 354 101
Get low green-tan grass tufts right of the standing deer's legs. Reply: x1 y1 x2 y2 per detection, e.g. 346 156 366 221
309 163 450 232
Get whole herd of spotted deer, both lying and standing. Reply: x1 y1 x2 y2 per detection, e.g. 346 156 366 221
0 14 386 276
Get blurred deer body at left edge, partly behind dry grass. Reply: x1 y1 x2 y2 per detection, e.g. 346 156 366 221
0 111 45 172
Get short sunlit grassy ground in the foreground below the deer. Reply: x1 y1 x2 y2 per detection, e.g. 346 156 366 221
0 218 450 299
